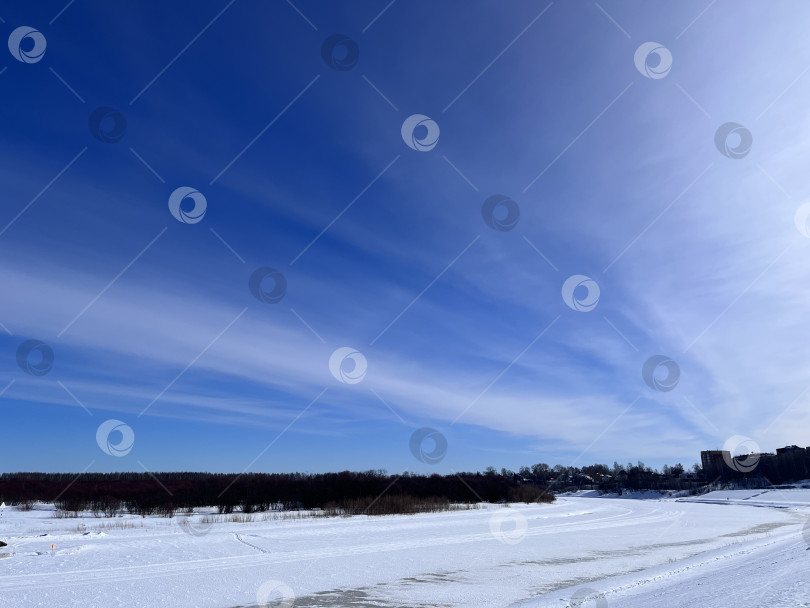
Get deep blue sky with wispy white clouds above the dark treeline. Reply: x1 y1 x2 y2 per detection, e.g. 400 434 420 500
0 0 810 473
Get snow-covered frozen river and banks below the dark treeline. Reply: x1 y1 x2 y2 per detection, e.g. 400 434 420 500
0 490 810 608
